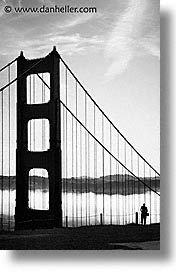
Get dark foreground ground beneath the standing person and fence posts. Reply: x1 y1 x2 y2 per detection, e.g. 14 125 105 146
0 224 160 250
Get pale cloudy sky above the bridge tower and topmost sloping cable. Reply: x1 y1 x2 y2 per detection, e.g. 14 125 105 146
0 0 160 174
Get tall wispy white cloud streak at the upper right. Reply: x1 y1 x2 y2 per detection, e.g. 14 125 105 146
105 0 159 79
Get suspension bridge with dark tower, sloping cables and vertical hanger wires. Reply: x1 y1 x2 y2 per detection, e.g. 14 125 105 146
0 47 160 230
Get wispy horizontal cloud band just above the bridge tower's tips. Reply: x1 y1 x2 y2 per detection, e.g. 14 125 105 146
0 21 102 58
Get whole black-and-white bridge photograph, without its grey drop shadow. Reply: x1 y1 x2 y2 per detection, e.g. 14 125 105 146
0 0 160 252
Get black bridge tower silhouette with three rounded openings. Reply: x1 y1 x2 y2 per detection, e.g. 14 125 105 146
15 48 62 230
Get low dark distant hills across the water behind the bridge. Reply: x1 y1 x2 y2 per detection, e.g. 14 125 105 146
0 174 160 195
